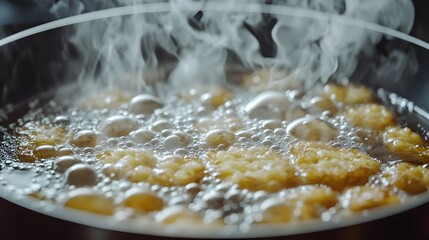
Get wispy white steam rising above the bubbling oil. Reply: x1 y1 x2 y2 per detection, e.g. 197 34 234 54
60 0 415 96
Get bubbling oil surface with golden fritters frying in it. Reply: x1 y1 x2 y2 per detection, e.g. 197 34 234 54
0 80 429 229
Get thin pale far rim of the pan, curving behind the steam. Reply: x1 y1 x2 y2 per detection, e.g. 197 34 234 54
0 0 429 50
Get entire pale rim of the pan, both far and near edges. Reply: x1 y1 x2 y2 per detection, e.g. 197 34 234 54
0 3 429 239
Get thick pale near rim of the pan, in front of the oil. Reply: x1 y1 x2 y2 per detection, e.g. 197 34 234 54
0 182 429 239
